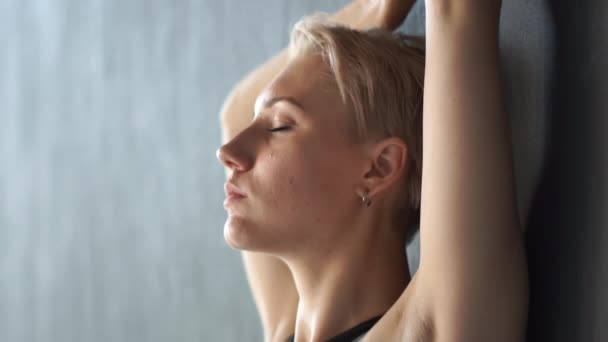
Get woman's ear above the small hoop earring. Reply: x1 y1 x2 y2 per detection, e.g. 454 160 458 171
363 137 408 197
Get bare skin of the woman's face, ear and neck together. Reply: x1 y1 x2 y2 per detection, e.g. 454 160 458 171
218 56 409 341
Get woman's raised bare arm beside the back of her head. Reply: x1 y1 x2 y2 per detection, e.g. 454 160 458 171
418 0 528 341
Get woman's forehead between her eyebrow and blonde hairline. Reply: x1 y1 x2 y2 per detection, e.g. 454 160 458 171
255 56 342 113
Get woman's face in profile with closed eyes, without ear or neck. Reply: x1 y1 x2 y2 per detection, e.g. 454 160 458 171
218 56 365 252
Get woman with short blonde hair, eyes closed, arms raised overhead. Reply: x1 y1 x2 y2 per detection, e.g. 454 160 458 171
218 0 528 341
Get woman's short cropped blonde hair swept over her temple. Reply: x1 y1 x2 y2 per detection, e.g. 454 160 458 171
288 13 424 242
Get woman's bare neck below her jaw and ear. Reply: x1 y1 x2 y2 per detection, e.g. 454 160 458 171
283 214 410 341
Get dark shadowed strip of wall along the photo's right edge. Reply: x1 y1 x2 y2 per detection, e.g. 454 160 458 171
526 0 608 342
